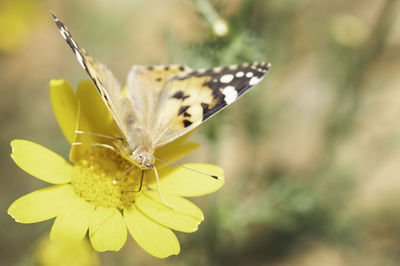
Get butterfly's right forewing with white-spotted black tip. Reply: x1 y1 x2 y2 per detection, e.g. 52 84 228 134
153 62 270 147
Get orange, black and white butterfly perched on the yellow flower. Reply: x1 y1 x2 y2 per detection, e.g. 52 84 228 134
51 12 271 177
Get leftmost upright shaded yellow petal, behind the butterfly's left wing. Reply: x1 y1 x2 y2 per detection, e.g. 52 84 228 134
50 79 78 143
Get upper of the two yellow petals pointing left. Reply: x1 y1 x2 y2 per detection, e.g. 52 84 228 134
11 139 72 184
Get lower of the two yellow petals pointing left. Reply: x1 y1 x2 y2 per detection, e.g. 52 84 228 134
8 185 77 223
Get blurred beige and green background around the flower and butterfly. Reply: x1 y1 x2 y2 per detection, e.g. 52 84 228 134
0 0 400 266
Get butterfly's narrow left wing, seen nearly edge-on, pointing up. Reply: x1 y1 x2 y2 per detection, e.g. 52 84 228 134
51 12 133 142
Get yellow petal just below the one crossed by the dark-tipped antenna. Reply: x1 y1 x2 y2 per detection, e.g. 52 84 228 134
136 191 204 233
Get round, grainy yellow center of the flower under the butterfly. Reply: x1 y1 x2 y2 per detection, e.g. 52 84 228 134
71 148 146 210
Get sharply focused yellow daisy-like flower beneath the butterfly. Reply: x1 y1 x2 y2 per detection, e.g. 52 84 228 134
8 80 224 258
